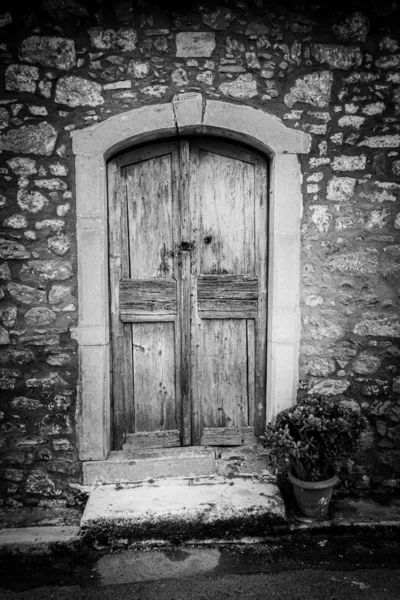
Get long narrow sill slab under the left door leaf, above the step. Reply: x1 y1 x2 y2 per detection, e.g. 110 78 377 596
83 446 216 485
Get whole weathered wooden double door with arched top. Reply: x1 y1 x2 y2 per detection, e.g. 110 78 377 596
108 138 267 448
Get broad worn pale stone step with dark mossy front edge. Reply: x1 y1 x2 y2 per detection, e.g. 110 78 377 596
81 476 286 545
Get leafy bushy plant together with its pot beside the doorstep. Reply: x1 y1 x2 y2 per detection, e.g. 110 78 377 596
261 397 366 517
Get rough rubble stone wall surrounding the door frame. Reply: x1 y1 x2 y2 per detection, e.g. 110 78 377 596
0 0 400 506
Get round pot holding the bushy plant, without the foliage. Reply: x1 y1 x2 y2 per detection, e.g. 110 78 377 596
288 472 339 518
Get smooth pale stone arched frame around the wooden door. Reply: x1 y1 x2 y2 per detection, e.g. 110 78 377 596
72 93 311 460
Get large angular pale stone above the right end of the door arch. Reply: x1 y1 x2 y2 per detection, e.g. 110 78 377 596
284 71 333 108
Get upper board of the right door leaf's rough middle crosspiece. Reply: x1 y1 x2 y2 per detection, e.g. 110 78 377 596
197 275 258 300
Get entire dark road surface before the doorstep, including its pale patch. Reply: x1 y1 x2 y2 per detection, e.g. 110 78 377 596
0 529 400 600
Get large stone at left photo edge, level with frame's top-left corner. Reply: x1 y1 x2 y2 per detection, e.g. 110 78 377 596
0 121 57 156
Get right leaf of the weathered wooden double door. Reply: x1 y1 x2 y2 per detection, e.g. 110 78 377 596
189 141 267 445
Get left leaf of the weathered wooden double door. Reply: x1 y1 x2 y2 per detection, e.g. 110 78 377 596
108 143 181 449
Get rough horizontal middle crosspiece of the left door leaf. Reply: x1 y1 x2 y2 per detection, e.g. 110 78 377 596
119 278 177 314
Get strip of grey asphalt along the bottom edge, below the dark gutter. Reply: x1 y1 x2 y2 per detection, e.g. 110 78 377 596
0 569 400 600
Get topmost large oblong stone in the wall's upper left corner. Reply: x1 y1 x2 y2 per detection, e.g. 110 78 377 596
19 35 76 71
